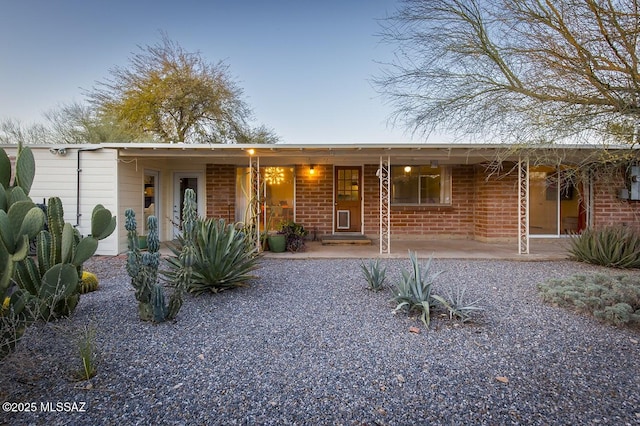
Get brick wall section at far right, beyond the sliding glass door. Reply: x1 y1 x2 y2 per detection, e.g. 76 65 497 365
593 170 640 230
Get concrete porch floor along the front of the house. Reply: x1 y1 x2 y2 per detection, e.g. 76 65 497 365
263 238 569 261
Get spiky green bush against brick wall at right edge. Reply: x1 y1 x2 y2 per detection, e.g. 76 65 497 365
569 226 640 268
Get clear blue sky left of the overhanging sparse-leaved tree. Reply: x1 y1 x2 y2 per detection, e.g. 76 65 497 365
0 0 424 144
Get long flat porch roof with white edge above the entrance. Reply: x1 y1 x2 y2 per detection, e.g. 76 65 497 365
100 143 628 165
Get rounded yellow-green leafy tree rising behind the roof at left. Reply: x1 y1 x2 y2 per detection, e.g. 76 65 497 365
88 34 272 143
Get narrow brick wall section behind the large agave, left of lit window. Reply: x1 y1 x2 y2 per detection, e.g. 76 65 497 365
205 164 236 221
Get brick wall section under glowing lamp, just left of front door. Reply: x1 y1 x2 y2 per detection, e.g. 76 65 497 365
295 165 333 237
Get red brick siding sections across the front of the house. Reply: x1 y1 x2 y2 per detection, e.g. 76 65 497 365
206 164 640 241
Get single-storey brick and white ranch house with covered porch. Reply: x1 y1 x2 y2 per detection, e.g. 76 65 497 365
4 143 640 255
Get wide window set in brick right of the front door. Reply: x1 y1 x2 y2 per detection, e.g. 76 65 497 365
391 166 451 205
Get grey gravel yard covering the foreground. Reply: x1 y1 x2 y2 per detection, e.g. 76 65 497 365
0 257 640 425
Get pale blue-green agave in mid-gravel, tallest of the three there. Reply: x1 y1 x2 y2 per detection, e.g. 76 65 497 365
392 250 442 327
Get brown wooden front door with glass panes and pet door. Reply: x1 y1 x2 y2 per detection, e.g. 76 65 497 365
334 166 362 232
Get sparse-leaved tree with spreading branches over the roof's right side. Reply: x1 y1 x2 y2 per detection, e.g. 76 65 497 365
376 0 640 144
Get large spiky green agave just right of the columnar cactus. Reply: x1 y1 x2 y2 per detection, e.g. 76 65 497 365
167 219 259 294
